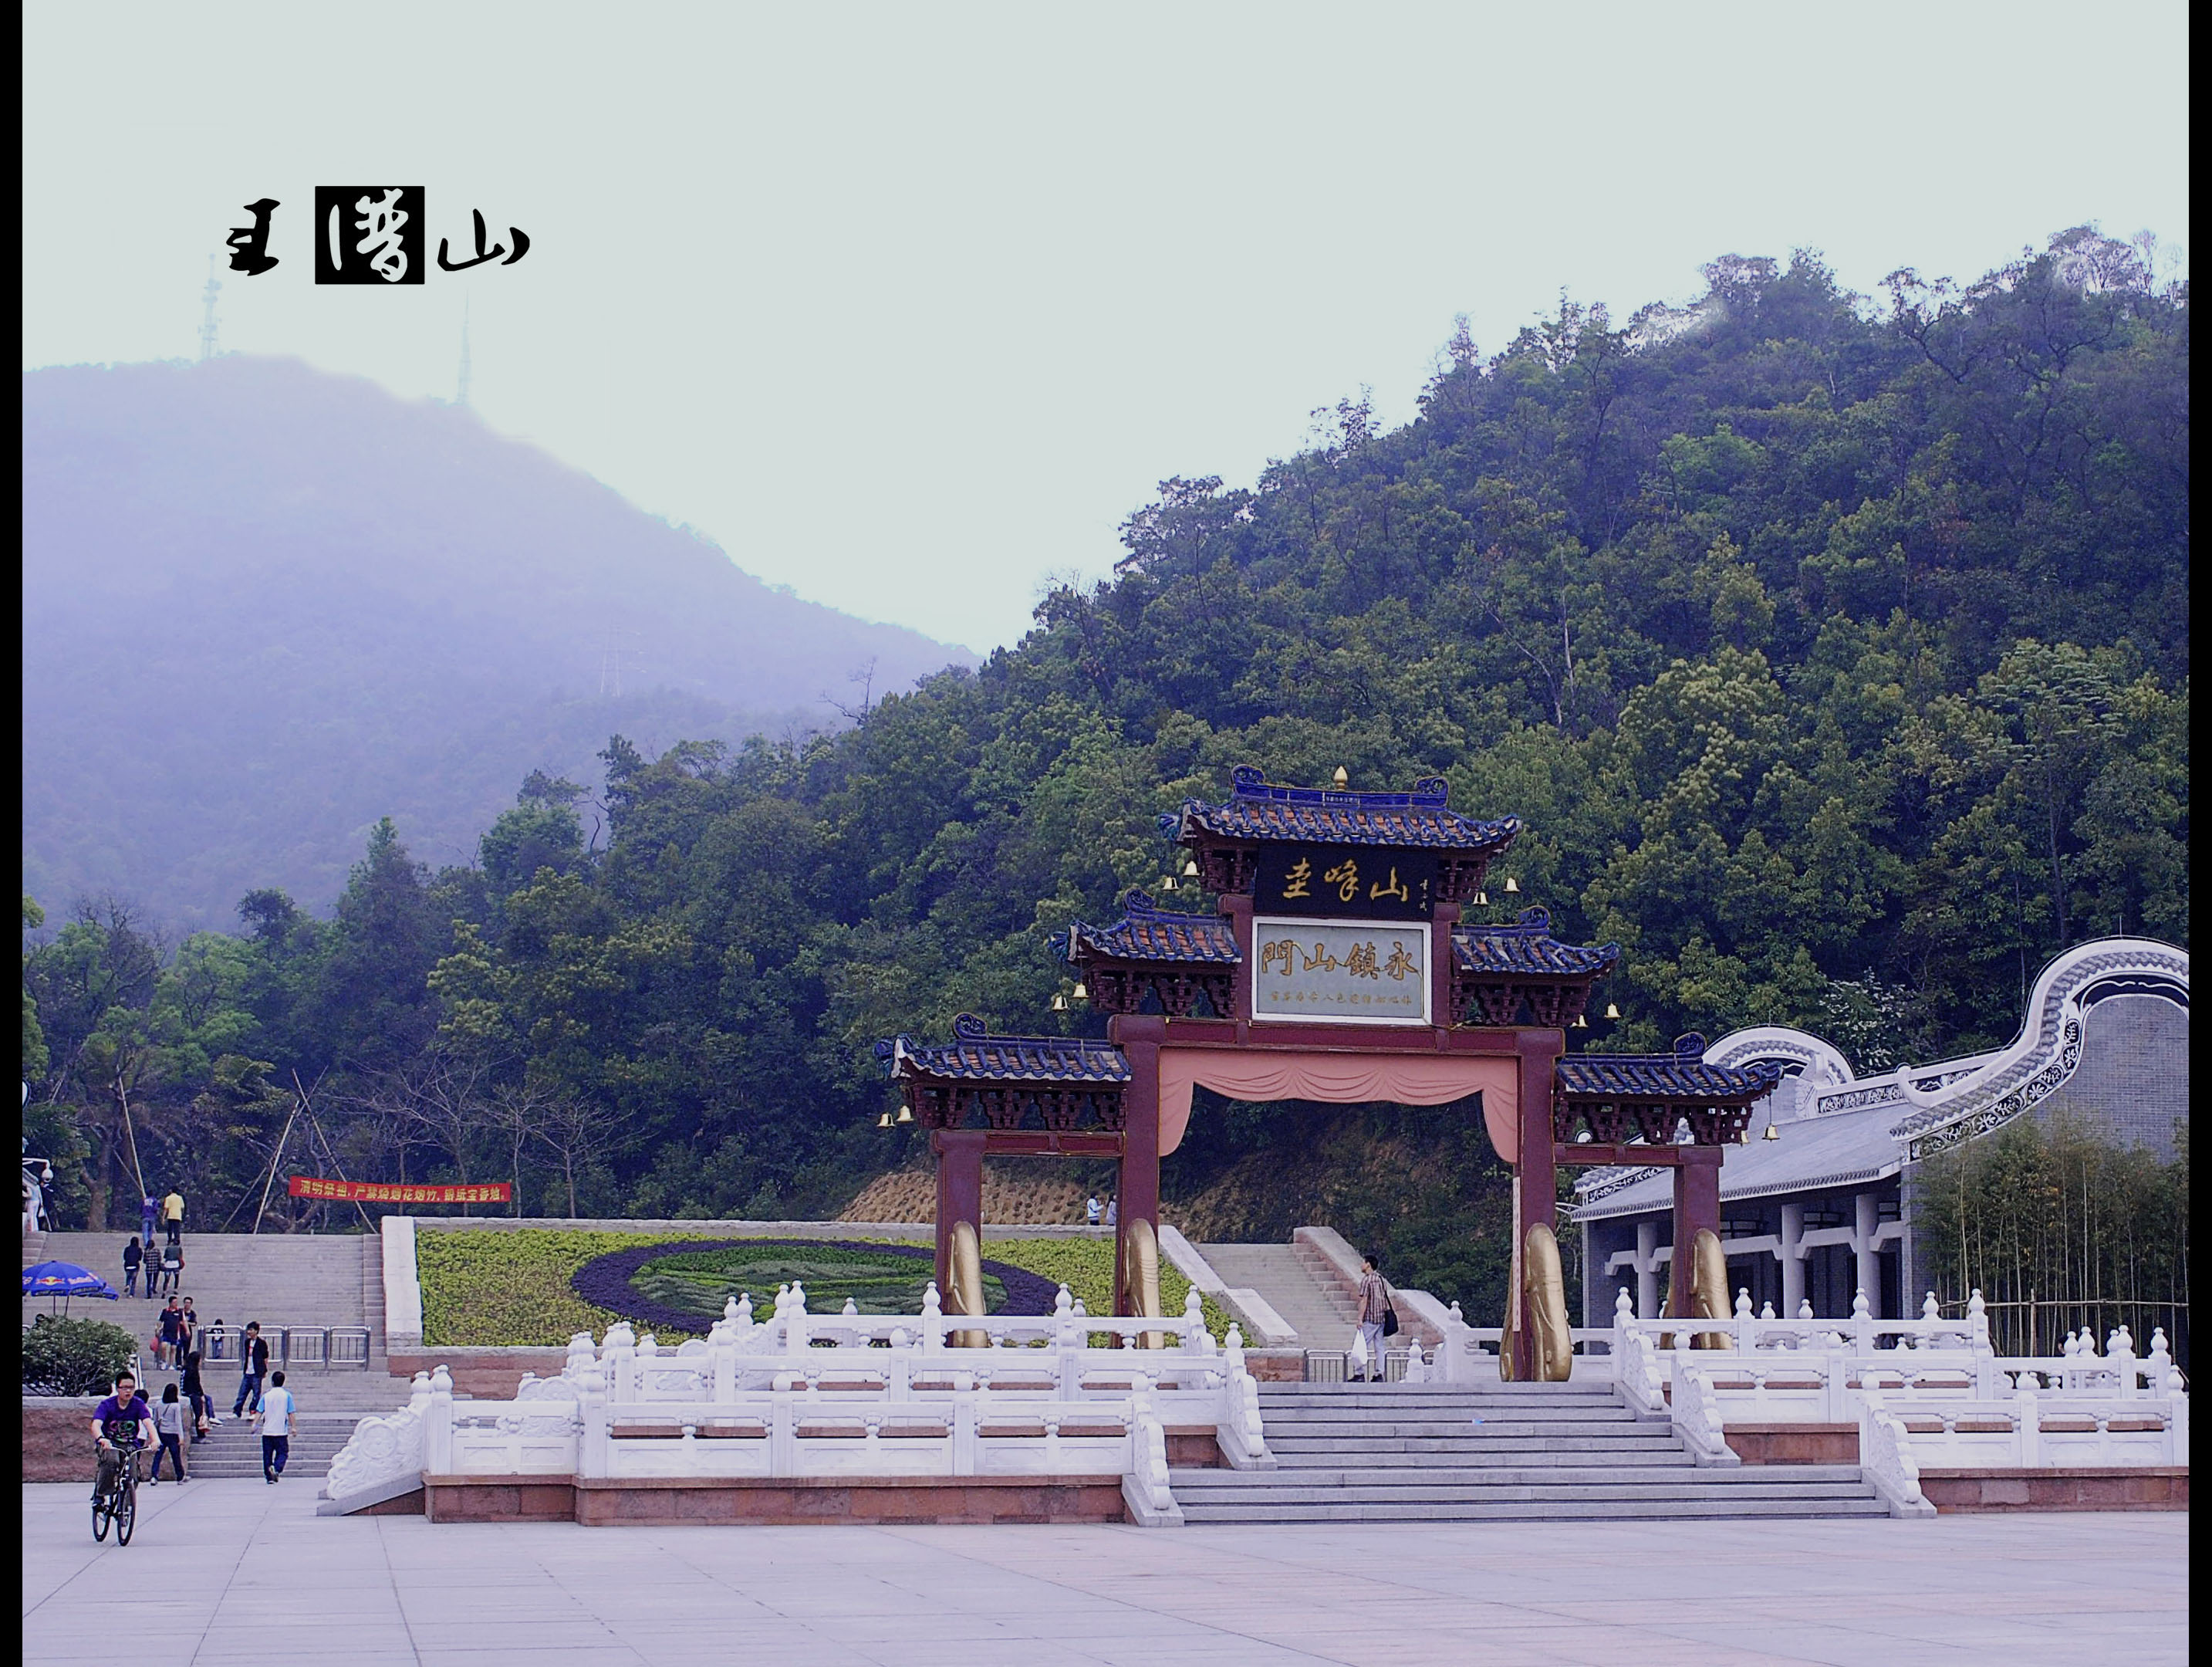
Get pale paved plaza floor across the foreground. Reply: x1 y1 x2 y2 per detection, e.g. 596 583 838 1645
22 1481 2187 1667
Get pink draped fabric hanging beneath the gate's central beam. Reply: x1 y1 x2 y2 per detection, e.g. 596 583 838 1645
1159 1047 1520 1165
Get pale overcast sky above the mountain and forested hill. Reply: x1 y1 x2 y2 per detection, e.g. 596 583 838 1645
22 2 2190 651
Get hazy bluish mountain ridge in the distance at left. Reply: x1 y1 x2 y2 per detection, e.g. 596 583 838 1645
22 357 971 928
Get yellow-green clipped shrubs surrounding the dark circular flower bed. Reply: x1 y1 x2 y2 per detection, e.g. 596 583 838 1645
416 1226 1230 1348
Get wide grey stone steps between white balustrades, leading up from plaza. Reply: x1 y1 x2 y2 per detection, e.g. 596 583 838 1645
1170 1384 1887 1523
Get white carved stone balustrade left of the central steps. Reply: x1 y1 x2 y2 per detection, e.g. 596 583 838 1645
327 1287 1274 1521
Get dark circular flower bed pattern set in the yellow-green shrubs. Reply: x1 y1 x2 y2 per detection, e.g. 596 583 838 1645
569 1238 1059 1335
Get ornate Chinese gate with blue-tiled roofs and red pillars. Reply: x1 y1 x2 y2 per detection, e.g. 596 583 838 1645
876 768 1778 1379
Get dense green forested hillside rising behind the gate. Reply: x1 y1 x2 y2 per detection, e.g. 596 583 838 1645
26 232 2187 1293
